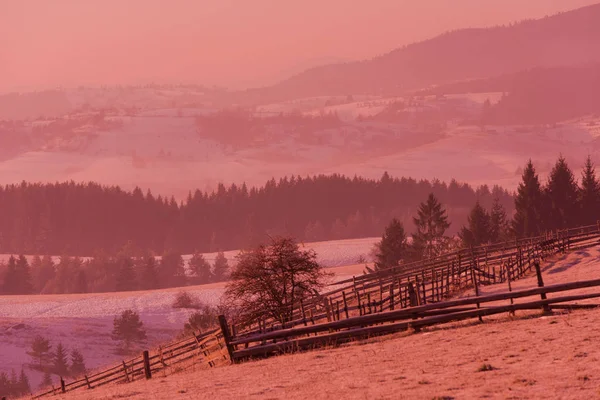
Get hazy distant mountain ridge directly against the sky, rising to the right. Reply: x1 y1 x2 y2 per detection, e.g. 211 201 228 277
236 4 600 104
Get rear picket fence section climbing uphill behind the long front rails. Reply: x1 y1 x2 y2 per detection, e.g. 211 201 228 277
231 225 600 335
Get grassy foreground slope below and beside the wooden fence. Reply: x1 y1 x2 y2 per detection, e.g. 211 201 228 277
52 248 600 399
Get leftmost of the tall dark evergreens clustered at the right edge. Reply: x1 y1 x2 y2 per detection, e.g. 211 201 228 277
512 160 542 237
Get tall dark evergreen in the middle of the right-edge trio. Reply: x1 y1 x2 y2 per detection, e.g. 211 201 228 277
545 156 579 229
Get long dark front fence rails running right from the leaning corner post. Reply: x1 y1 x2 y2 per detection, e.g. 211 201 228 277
221 279 600 361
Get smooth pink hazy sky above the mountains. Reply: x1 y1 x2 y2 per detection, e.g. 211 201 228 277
0 0 600 92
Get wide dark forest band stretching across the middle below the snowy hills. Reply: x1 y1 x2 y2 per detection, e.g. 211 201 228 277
0 173 514 256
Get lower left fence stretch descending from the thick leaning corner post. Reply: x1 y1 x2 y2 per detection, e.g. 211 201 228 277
33 329 229 399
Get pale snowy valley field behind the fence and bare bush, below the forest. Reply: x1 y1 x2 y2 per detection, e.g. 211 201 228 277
0 238 377 386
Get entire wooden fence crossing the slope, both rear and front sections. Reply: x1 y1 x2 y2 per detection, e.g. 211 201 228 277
34 224 600 398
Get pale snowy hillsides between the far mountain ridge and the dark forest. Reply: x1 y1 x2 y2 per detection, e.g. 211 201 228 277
0 93 600 199
